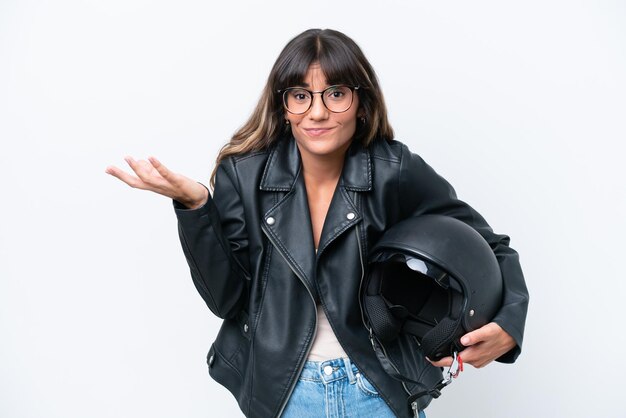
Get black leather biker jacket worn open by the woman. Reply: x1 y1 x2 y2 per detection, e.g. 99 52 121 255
174 137 528 417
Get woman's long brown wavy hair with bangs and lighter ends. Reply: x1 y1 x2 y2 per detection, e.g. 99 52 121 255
211 29 393 187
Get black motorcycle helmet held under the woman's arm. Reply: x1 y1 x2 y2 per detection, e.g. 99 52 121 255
362 215 502 360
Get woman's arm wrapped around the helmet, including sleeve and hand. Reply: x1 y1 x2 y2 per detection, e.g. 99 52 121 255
399 146 528 367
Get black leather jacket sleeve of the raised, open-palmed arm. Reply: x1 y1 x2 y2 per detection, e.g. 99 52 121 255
173 160 250 318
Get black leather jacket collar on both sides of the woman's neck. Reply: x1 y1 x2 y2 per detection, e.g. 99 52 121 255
260 135 372 192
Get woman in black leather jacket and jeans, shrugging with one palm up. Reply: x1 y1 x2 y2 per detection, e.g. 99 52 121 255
107 29 528 417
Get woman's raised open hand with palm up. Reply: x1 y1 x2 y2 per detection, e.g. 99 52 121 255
105 157 209 209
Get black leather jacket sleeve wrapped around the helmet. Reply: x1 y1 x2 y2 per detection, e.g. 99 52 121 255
398 146 529 363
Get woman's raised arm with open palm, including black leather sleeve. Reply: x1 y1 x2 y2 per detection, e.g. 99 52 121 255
106 157 248 318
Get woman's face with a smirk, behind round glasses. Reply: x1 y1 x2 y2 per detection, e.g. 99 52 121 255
285 63 359 161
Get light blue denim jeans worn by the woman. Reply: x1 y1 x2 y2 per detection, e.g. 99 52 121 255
281 358 426 418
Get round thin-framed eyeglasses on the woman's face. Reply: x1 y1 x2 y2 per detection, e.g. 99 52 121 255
277 85 359 115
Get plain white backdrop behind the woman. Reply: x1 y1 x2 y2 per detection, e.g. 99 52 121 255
0 0 626 418
